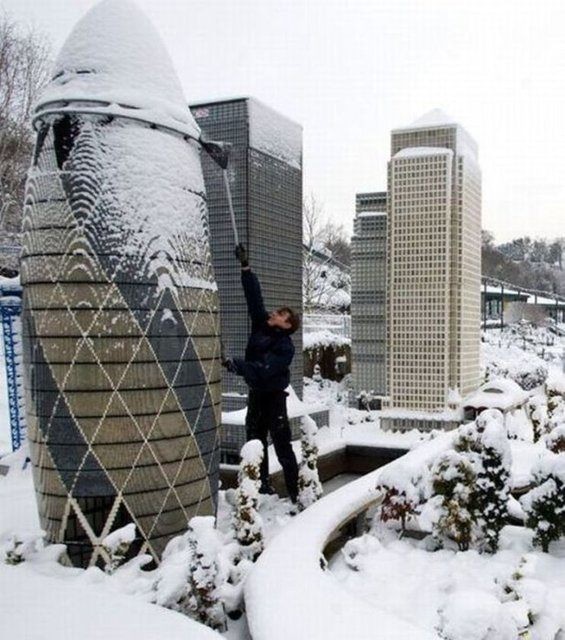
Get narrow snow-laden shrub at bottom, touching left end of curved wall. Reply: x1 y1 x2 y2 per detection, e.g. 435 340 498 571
185 516 226 629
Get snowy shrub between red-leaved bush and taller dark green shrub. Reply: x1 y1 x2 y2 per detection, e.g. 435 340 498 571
432 451 476 551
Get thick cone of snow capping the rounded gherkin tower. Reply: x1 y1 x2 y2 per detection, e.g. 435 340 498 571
37 0 200 137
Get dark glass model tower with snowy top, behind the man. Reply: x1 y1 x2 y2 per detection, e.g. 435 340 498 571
191 98 303 458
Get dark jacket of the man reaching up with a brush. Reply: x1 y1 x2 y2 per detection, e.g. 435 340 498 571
233 269 294 391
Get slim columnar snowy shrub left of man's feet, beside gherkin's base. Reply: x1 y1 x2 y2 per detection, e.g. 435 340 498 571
233 440 263 561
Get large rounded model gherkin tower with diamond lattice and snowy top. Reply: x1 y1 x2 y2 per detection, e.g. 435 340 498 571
21 0 220 566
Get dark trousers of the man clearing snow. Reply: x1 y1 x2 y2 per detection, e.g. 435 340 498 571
245 389 298 501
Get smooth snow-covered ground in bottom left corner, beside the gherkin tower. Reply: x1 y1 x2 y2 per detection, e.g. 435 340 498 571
0 445 225 640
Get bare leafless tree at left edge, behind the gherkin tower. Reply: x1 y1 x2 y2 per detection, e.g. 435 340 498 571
0 13 50 267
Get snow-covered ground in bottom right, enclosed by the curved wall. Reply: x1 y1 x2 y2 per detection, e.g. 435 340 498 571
331 527 565 640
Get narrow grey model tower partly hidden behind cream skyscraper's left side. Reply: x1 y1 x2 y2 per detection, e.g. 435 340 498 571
351 192 387 408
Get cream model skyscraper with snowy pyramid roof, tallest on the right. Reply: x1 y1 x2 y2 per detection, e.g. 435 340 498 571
387 110 481 420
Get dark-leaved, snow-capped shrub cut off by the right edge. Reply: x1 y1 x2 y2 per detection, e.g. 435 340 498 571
520 451 565 552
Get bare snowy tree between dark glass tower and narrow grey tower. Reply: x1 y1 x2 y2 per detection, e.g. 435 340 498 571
303 194 350 313
